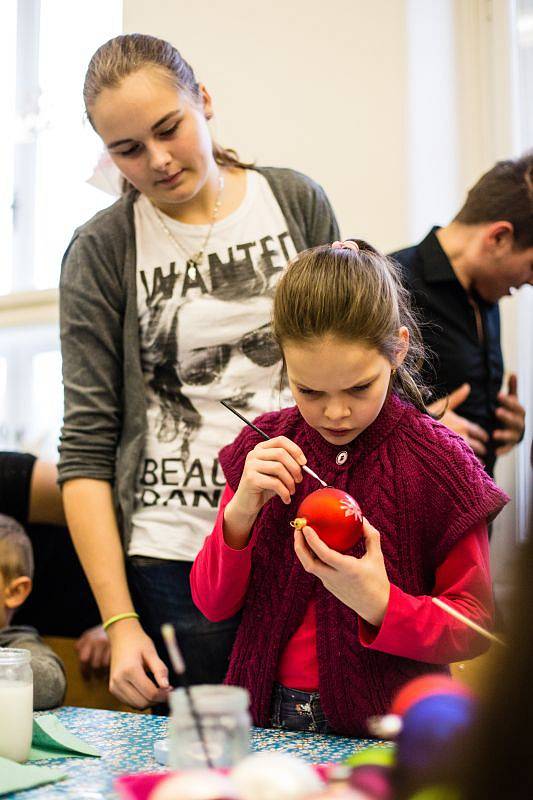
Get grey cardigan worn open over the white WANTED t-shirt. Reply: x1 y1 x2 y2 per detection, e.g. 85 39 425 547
59 167 339 548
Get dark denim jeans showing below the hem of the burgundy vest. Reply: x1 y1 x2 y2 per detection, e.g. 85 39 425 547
270 683 333 733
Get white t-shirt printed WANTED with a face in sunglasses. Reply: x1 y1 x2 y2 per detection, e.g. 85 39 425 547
128 170 296 561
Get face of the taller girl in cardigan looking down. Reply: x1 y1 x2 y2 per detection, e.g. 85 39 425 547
91 69 216 212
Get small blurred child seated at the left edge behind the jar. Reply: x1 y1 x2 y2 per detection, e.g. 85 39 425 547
0 514 67 711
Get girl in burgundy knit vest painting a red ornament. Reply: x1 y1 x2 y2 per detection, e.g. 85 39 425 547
191 242 507 735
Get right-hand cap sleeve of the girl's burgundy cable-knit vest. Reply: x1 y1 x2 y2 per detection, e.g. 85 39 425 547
402 412 509 570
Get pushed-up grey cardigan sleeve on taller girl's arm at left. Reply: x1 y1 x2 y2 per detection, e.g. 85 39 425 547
58 231 123 483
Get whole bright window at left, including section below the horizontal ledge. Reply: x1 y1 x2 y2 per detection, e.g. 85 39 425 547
0 0 122 459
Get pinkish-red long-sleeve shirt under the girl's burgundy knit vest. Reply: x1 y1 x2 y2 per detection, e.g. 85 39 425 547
191 486 493 692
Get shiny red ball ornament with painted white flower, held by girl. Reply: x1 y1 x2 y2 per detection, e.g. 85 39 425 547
291 486 363 553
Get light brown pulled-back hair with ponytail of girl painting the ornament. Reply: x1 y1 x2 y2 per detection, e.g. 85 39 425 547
273 239 436 413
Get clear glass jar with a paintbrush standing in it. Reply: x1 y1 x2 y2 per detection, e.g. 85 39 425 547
169 685 251 769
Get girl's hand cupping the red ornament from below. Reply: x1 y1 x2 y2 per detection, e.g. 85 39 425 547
294 517 390 627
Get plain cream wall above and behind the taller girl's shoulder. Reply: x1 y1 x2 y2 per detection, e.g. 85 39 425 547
124 0 409 249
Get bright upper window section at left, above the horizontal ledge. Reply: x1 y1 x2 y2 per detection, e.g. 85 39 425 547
0 0 122 292
